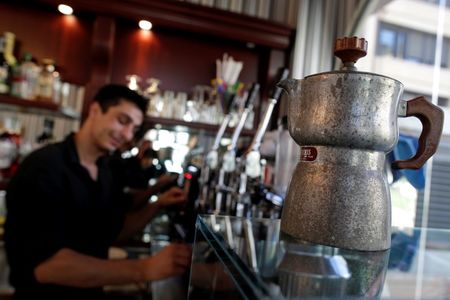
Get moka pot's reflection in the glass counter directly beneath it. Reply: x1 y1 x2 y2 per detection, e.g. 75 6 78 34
278 244 389 300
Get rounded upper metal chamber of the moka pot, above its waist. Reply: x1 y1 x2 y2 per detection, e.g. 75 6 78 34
286 71 403 151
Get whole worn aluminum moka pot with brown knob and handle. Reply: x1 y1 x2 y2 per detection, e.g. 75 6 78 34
279 37 444 251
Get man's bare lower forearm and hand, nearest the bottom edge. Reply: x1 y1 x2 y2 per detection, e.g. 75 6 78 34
34 244 192 288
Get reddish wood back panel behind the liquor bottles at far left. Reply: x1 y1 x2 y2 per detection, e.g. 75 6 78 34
0 3 92 84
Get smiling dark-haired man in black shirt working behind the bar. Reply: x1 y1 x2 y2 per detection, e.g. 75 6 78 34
5 85 191 299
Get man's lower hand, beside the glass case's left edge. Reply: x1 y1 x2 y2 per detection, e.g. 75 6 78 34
145 244 192 280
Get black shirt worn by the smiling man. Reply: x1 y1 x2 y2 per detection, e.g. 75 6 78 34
5 134 130 299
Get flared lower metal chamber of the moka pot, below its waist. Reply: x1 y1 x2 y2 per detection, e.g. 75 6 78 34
281 146 391 251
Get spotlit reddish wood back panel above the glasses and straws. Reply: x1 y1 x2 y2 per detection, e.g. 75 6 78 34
112 22 260 92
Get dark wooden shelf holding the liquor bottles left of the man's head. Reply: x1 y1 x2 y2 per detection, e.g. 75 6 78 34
0 95 80 119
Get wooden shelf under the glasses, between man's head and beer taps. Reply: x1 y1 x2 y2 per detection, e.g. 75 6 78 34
145 117 256 136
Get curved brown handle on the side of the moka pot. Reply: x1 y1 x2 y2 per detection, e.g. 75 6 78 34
392 96 444 169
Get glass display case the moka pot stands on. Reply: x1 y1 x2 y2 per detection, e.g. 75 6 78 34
188 215 450 299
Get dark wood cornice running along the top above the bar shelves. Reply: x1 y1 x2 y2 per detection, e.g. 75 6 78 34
39 0 294 49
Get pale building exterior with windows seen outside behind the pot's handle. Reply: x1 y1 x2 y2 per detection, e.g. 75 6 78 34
358 0 450 228
